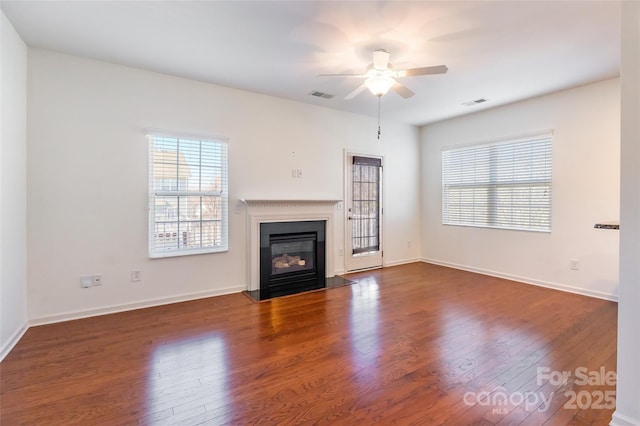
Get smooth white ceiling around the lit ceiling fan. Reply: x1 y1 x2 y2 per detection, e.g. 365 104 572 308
1 0 620 125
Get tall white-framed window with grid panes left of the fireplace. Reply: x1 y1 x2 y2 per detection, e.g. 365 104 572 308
148 134 228 257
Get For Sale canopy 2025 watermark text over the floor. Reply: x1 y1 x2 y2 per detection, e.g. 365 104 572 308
463 366 617 415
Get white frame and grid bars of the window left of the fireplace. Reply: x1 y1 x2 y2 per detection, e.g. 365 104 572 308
146 129 229 259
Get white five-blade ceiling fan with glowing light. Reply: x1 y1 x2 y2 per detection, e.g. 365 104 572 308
320 49 448 100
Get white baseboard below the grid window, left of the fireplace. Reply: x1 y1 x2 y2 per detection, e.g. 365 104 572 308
29 286 246 327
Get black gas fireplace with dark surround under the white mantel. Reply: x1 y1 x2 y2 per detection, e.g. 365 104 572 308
260 220 326 300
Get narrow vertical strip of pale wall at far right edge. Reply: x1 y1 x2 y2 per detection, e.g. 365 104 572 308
611 2 640 426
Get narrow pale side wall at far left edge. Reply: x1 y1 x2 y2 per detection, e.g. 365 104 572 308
0 12 27 360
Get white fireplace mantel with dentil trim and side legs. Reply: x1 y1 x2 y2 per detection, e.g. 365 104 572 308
240 199 342 291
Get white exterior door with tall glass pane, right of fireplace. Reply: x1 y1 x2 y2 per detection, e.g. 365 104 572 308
345 154 382 272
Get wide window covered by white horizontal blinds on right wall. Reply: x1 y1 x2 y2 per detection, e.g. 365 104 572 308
442 133 551 232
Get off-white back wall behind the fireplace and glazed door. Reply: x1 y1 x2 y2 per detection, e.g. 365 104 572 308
28 49 420 323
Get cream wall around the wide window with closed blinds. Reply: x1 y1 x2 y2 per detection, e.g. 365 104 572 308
421 79 620 299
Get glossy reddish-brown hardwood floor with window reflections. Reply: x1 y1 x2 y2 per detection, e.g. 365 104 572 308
0 263 617 426
